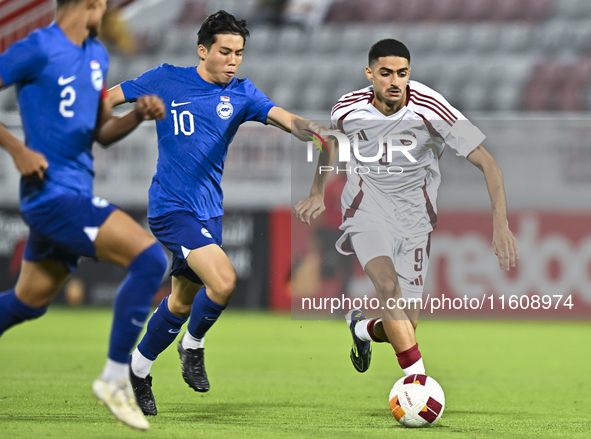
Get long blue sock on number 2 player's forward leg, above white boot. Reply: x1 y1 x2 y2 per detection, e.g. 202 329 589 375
109 243 168 363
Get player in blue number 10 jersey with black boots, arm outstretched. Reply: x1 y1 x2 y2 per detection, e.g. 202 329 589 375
109 11 328 415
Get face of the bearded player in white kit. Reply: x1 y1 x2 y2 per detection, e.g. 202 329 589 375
365 56 410 106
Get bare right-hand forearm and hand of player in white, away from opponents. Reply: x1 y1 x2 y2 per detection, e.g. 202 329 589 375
467 145 519 271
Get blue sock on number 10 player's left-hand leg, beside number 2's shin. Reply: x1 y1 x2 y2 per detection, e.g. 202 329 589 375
137 297 187 361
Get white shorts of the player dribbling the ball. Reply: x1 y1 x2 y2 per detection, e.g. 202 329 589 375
348 230 431 299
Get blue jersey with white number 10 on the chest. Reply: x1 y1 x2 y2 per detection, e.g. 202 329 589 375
121 64 275 220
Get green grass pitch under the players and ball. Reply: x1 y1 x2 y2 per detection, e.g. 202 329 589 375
0 307 591 439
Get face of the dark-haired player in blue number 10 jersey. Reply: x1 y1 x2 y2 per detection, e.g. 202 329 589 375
199 34 244 84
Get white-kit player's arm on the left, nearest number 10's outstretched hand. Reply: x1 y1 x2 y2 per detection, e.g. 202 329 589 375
294 137 338 225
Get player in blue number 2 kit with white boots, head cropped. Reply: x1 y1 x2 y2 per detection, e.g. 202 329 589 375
0 0 167 430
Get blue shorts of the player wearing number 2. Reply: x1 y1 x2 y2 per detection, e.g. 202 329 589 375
22 194 117 272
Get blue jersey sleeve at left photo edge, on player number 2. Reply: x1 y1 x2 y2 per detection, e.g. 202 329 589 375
0 33 47 86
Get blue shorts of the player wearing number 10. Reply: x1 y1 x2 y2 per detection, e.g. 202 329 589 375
148 210 222 285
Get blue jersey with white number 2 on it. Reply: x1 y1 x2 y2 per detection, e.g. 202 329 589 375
0 23 109 211
